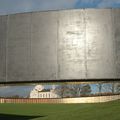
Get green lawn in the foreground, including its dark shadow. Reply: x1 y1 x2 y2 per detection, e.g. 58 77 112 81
0 101 120 120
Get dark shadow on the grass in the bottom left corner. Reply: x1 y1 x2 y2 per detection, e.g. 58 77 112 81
0 113 45 120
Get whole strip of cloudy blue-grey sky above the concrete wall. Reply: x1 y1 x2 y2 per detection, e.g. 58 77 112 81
0 0 120 15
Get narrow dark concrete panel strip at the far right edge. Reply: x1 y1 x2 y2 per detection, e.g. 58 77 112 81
112 9 120 78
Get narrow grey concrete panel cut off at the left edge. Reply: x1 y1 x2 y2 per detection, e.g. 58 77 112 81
0 16 7 82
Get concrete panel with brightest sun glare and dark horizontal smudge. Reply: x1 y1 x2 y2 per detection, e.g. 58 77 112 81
58 10 86 79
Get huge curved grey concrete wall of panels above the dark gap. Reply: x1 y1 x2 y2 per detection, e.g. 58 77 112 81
0 9 120 82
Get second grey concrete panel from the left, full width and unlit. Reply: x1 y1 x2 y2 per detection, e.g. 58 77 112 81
7 13 31 81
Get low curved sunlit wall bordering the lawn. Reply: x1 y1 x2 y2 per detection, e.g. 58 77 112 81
0 95 120 103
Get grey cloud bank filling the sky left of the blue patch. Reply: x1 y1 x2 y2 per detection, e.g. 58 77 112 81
0 0 78 14
